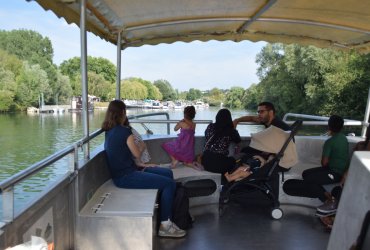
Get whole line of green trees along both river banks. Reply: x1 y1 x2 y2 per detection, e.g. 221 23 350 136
0 30 370 119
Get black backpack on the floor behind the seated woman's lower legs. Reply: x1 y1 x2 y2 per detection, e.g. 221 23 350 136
172 182 193 230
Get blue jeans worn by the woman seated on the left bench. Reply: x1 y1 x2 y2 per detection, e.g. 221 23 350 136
113 167 176 221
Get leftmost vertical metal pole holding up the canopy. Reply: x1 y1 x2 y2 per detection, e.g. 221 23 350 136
80 0 90 159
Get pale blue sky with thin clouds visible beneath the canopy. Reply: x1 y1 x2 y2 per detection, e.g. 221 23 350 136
0 0 266 91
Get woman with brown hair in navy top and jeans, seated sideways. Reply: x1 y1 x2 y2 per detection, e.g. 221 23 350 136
102 100 186 238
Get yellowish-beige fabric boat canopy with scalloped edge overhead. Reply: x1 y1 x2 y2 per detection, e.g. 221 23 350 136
36 0 370 52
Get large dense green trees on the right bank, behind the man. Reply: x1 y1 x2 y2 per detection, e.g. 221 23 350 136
253 44 369 118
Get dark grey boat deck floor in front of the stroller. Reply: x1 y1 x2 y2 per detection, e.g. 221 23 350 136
157 203 330 250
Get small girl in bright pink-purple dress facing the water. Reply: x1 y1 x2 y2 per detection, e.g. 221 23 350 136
162 106 196 168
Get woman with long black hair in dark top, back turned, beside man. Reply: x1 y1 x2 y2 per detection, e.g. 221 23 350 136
202 109 241 178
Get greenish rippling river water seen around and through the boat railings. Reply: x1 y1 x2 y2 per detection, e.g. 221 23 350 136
0 107 262 216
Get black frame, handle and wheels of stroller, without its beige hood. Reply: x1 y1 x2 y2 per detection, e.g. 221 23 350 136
219 120 302 219
